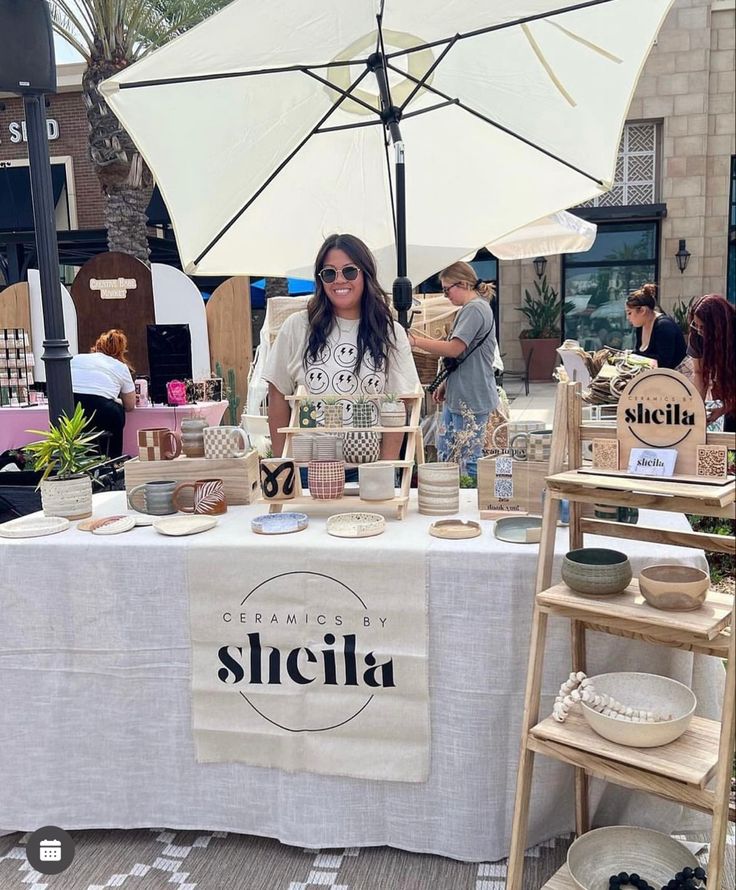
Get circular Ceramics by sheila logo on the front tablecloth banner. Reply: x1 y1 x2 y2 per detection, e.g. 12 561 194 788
217 572 396 732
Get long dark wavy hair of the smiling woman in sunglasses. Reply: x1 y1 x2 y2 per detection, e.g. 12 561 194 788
304 234 395 374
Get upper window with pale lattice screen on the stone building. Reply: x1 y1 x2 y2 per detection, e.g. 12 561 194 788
580 121 659 207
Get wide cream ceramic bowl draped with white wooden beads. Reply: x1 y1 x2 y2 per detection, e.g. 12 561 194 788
582 672 697 748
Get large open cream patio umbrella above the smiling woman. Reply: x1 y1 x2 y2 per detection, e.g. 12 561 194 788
101 0 672 326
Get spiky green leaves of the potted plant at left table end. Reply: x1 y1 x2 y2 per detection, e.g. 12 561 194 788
23 405 105 481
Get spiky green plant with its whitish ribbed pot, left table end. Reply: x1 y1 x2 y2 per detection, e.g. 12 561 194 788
23 405 105 519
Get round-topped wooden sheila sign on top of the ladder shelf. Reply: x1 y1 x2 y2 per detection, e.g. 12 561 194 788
616 368 706 476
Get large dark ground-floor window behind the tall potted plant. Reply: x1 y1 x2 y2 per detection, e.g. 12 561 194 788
562 221 659 350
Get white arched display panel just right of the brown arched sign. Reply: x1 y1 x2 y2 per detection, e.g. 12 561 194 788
151 263 211 380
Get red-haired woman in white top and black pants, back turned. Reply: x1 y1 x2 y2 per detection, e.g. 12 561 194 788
72 329 135 457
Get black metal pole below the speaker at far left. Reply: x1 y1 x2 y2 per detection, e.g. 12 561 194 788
23 93 74 424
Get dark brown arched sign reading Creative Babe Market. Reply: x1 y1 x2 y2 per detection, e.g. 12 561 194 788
71 253 156 374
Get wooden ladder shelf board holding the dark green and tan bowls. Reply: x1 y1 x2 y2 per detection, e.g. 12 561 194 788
537 580 734 640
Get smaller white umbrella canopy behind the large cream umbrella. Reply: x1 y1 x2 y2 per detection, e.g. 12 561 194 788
486 210 598 260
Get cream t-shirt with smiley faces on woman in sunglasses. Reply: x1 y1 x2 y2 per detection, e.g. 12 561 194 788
262 310 420 423
